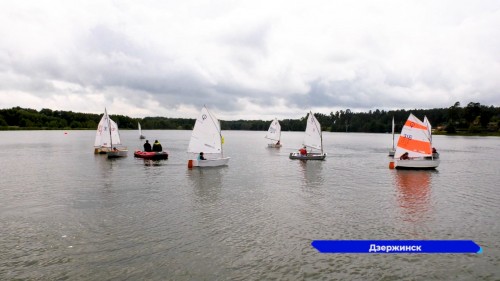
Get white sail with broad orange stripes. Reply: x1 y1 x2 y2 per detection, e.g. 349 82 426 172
394 113 432 159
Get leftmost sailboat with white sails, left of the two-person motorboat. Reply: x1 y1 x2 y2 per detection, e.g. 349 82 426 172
94 108 128 158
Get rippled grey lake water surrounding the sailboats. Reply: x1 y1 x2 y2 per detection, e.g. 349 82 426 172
0 131 500 280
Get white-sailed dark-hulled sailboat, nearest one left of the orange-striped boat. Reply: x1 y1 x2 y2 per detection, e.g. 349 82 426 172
290 111 326 160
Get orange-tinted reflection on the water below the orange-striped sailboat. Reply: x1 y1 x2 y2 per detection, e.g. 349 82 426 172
395 170 435 222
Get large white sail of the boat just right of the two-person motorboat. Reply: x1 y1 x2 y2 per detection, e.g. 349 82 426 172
188 107 222 156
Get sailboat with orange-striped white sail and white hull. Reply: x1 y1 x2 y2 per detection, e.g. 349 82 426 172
393 113 439 169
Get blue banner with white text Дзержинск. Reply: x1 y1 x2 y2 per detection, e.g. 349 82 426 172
311 240 483 254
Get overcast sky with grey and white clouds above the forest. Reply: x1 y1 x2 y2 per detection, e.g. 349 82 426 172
0 0 500 120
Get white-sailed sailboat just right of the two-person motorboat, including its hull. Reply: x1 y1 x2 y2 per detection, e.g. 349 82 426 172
188 106 229 168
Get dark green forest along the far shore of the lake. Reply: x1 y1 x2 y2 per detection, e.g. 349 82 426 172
0 102 500 135
